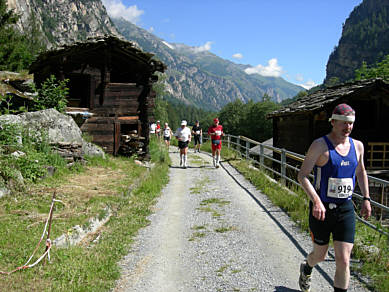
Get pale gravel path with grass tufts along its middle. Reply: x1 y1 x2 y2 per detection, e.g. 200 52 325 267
114 148 367 292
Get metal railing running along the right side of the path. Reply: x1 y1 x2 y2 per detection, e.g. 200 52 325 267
204 134 389 239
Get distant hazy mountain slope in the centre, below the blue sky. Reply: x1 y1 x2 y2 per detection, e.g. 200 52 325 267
113 19 304 110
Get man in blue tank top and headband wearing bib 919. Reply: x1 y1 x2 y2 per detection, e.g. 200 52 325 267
298 104 371 292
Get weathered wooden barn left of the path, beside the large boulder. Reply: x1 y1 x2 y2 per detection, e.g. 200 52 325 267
30 36 165 155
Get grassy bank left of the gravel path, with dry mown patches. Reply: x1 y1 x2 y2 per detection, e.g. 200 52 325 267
0 137 169 291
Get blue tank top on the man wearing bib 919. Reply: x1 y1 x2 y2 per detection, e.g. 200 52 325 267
314 136 358 203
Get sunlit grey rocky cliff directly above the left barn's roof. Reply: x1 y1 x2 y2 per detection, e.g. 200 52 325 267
7 0 119 48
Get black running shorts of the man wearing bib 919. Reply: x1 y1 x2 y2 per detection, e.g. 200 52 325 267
309 200 355 245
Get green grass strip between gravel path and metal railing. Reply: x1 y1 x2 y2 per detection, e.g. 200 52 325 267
217 143 389 291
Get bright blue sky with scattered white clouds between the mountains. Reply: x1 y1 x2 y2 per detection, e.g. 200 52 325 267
102 0 362 87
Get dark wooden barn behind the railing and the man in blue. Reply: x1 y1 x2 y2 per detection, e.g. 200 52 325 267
268 79 389 169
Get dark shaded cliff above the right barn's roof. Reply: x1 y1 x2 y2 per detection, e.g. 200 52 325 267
325 0 389 83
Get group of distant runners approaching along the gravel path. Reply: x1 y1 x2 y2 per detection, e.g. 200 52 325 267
150 118 224 168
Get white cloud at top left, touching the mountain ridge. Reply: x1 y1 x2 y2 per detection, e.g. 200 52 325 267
102 0 144 24
